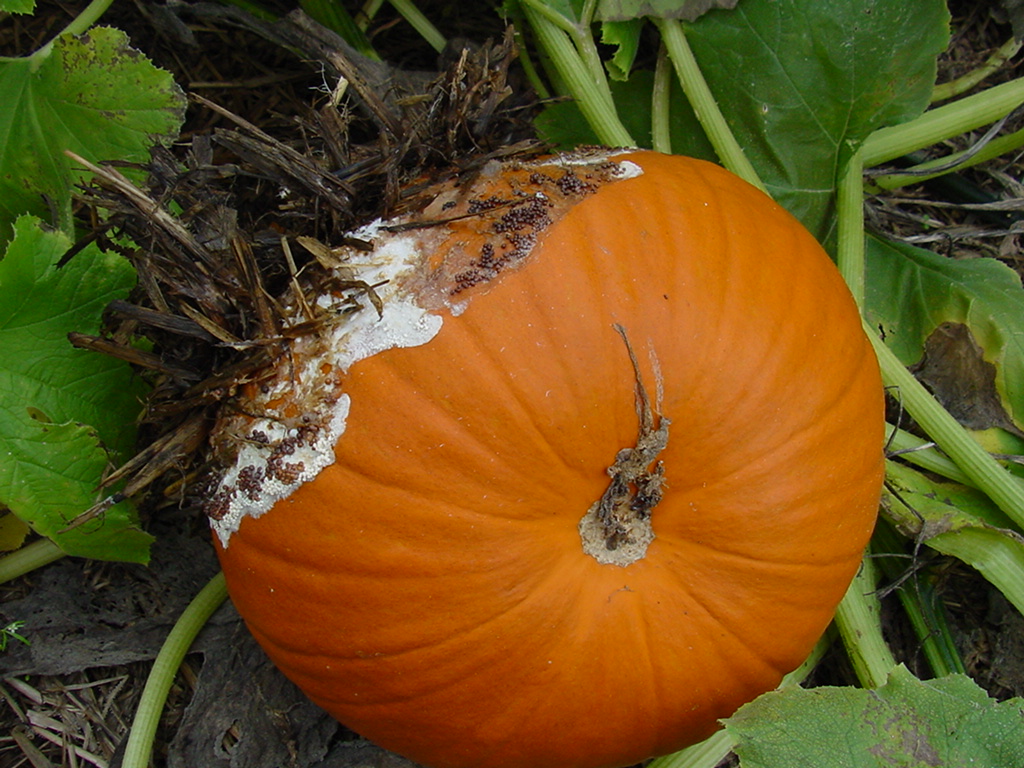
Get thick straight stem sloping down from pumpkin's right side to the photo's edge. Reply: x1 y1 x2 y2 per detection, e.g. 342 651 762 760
865 325 1024 526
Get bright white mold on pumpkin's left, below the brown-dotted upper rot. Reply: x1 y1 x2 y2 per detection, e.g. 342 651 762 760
207 221 442 547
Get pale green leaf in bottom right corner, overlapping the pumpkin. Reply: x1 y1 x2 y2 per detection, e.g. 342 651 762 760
725 667 1024 768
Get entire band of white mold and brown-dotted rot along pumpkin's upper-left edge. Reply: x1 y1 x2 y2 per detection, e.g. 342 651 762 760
206 150 643 547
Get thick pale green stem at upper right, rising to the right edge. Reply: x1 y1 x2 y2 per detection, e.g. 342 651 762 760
862 78 1024 168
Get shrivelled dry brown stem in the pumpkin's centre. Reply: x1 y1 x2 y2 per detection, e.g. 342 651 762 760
580 324 672 565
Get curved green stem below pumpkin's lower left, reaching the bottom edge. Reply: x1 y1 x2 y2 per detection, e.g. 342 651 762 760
121 572 227 768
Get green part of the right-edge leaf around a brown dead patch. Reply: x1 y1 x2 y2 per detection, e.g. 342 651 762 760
865 238 1024 434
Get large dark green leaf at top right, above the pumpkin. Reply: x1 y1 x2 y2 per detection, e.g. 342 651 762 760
687 0 949 240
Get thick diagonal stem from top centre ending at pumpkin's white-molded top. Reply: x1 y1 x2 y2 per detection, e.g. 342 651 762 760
522 0 636 146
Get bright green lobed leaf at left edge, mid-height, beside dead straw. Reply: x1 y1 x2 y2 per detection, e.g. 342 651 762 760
0 216 151 562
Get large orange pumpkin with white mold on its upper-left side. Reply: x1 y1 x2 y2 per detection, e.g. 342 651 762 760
209 151 883 768
